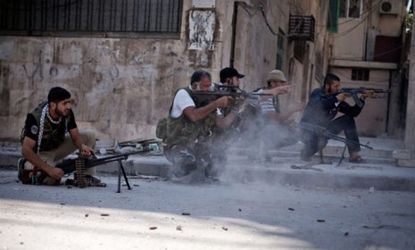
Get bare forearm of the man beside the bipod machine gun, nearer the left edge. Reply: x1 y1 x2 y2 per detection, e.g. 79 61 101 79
22 137 64 180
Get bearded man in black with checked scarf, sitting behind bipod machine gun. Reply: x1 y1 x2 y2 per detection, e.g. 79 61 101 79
18 87 100 185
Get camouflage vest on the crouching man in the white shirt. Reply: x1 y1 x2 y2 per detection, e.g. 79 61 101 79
156 88 216 148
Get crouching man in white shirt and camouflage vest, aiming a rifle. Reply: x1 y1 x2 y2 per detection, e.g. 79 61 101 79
156 70 233 180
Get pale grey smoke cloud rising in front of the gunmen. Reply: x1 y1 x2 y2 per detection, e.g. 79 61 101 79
211 97 300 183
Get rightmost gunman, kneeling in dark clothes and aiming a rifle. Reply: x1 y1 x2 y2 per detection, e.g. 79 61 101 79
301 73 370 163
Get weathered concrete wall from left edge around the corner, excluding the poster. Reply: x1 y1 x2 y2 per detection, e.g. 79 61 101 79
0 0 328 140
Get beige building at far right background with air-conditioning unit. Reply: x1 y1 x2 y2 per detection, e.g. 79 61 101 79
329 0 407 138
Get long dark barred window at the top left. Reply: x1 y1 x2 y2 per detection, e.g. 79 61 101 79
0 0 183 36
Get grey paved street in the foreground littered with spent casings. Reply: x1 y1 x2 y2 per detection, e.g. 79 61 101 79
0 170 415 250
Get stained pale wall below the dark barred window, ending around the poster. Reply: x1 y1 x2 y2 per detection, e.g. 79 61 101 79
0 0 224 140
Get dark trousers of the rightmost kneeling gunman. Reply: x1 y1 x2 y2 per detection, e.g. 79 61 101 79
301 115 360 159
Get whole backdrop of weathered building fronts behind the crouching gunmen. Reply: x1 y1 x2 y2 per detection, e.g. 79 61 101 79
0 0 412 169
